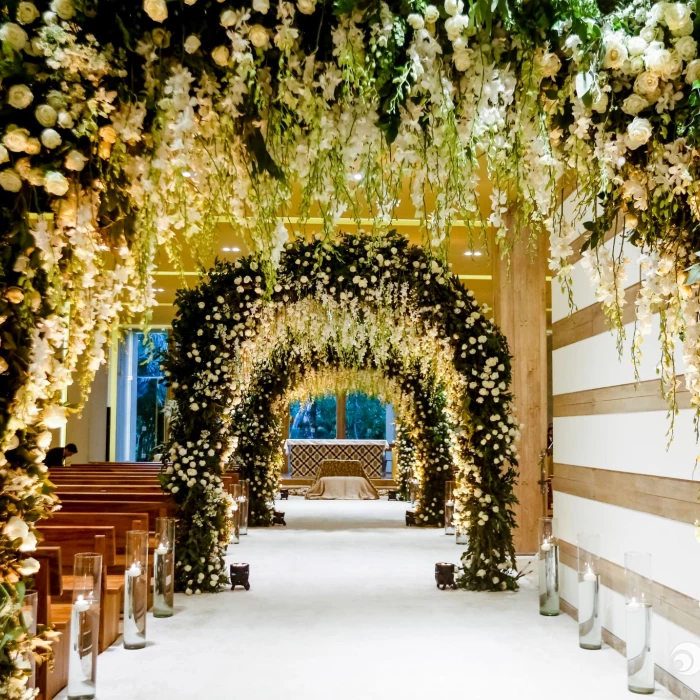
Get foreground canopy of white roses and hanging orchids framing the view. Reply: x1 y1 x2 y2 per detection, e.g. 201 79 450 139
0 0 700 699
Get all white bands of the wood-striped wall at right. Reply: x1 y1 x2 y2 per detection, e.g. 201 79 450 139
552 226 700 693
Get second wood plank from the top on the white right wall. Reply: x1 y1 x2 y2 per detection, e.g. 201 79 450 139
553 377 691 418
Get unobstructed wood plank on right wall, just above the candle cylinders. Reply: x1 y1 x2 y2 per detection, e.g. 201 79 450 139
552 463 700 523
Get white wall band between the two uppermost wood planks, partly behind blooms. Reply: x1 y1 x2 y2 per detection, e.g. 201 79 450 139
552 316 685 396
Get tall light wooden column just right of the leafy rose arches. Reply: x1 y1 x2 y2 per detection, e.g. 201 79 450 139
493 232 548 554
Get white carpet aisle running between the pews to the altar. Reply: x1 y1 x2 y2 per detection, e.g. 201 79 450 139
59 498 671 700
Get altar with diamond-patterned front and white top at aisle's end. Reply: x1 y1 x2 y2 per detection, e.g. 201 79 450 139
285 440 389 479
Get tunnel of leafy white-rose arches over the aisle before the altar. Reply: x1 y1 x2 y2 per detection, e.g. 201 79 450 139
164 232 518 593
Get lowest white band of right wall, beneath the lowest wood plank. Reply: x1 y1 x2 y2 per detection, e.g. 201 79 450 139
559 565 700 693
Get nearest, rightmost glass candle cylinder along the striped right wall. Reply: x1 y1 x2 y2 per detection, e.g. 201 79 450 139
625 552 654 695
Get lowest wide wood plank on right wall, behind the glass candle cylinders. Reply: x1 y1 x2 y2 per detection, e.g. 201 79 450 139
559 540 700 636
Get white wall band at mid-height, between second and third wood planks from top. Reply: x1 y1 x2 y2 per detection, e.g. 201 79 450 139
554 409 700 482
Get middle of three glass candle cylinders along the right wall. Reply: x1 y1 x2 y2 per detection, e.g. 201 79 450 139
578 533 603 649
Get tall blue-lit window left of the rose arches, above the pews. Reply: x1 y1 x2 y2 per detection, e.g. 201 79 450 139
116 331 168 462
